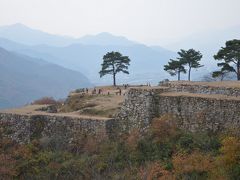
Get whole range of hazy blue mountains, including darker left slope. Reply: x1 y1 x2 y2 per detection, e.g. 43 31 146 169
0 24 236 108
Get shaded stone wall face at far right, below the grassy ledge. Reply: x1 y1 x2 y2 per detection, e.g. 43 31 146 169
157 94 240 132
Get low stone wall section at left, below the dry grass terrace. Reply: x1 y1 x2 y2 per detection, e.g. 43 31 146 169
0 113 112 143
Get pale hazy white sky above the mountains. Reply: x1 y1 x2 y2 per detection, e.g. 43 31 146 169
0 0 240 44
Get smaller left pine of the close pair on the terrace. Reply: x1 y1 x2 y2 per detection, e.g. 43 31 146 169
164 59 186 80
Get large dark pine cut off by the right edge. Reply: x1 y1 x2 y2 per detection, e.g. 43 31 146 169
214 39 240 80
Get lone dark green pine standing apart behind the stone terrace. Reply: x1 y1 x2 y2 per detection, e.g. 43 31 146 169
99 51 130 86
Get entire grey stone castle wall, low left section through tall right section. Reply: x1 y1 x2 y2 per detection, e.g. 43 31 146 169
0 82 240 144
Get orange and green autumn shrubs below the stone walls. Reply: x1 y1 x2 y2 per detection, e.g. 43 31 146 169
0 116 240 180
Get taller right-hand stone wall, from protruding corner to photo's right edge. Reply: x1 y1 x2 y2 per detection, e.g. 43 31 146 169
117 88 240 132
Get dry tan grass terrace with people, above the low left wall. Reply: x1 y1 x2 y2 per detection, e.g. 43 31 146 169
0 86 126 120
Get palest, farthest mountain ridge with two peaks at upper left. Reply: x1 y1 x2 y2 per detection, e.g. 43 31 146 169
0 23 138 46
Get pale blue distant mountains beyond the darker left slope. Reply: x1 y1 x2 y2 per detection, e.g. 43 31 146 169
0 24 220 88
